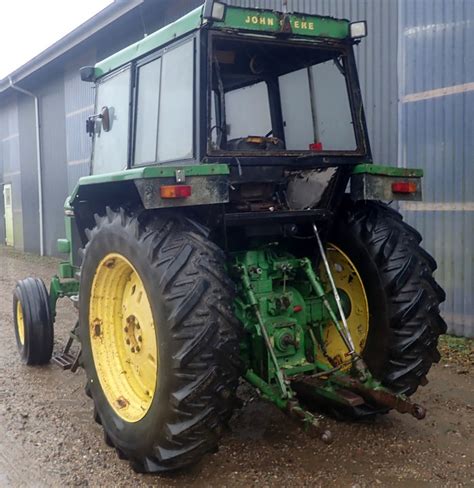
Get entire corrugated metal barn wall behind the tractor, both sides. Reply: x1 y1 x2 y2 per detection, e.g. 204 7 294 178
0 0 474 335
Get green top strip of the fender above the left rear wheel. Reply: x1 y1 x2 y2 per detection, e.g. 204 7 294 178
69 164 230 202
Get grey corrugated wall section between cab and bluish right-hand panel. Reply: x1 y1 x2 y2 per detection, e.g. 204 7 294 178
227 0 399 166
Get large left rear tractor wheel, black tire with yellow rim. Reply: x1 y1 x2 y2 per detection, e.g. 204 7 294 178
79 209 241 472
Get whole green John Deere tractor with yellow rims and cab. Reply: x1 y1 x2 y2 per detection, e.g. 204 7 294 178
14 0 446 473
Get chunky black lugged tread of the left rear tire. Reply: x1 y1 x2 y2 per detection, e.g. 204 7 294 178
80 208 242 473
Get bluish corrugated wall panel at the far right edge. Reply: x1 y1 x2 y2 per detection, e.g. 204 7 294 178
400 0 474 337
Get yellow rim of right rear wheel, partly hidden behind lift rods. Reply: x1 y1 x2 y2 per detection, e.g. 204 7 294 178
317 244 369 366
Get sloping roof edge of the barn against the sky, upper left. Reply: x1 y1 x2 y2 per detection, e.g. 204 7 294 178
0 0 144 95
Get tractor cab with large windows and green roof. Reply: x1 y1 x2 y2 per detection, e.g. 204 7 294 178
82 1 371 175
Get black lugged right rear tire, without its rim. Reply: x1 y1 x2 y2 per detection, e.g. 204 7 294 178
331 202 446 404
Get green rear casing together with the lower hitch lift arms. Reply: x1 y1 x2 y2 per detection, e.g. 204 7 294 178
228 244 422 425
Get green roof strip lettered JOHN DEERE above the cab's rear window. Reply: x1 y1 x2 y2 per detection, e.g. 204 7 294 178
218 7 349 39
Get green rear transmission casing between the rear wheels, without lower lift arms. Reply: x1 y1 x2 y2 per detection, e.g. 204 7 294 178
229 246 350 392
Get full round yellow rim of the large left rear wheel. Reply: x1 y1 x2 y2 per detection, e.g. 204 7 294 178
89 253 159 422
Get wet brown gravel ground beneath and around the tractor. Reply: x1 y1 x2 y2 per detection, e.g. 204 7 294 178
0 247 474 488
